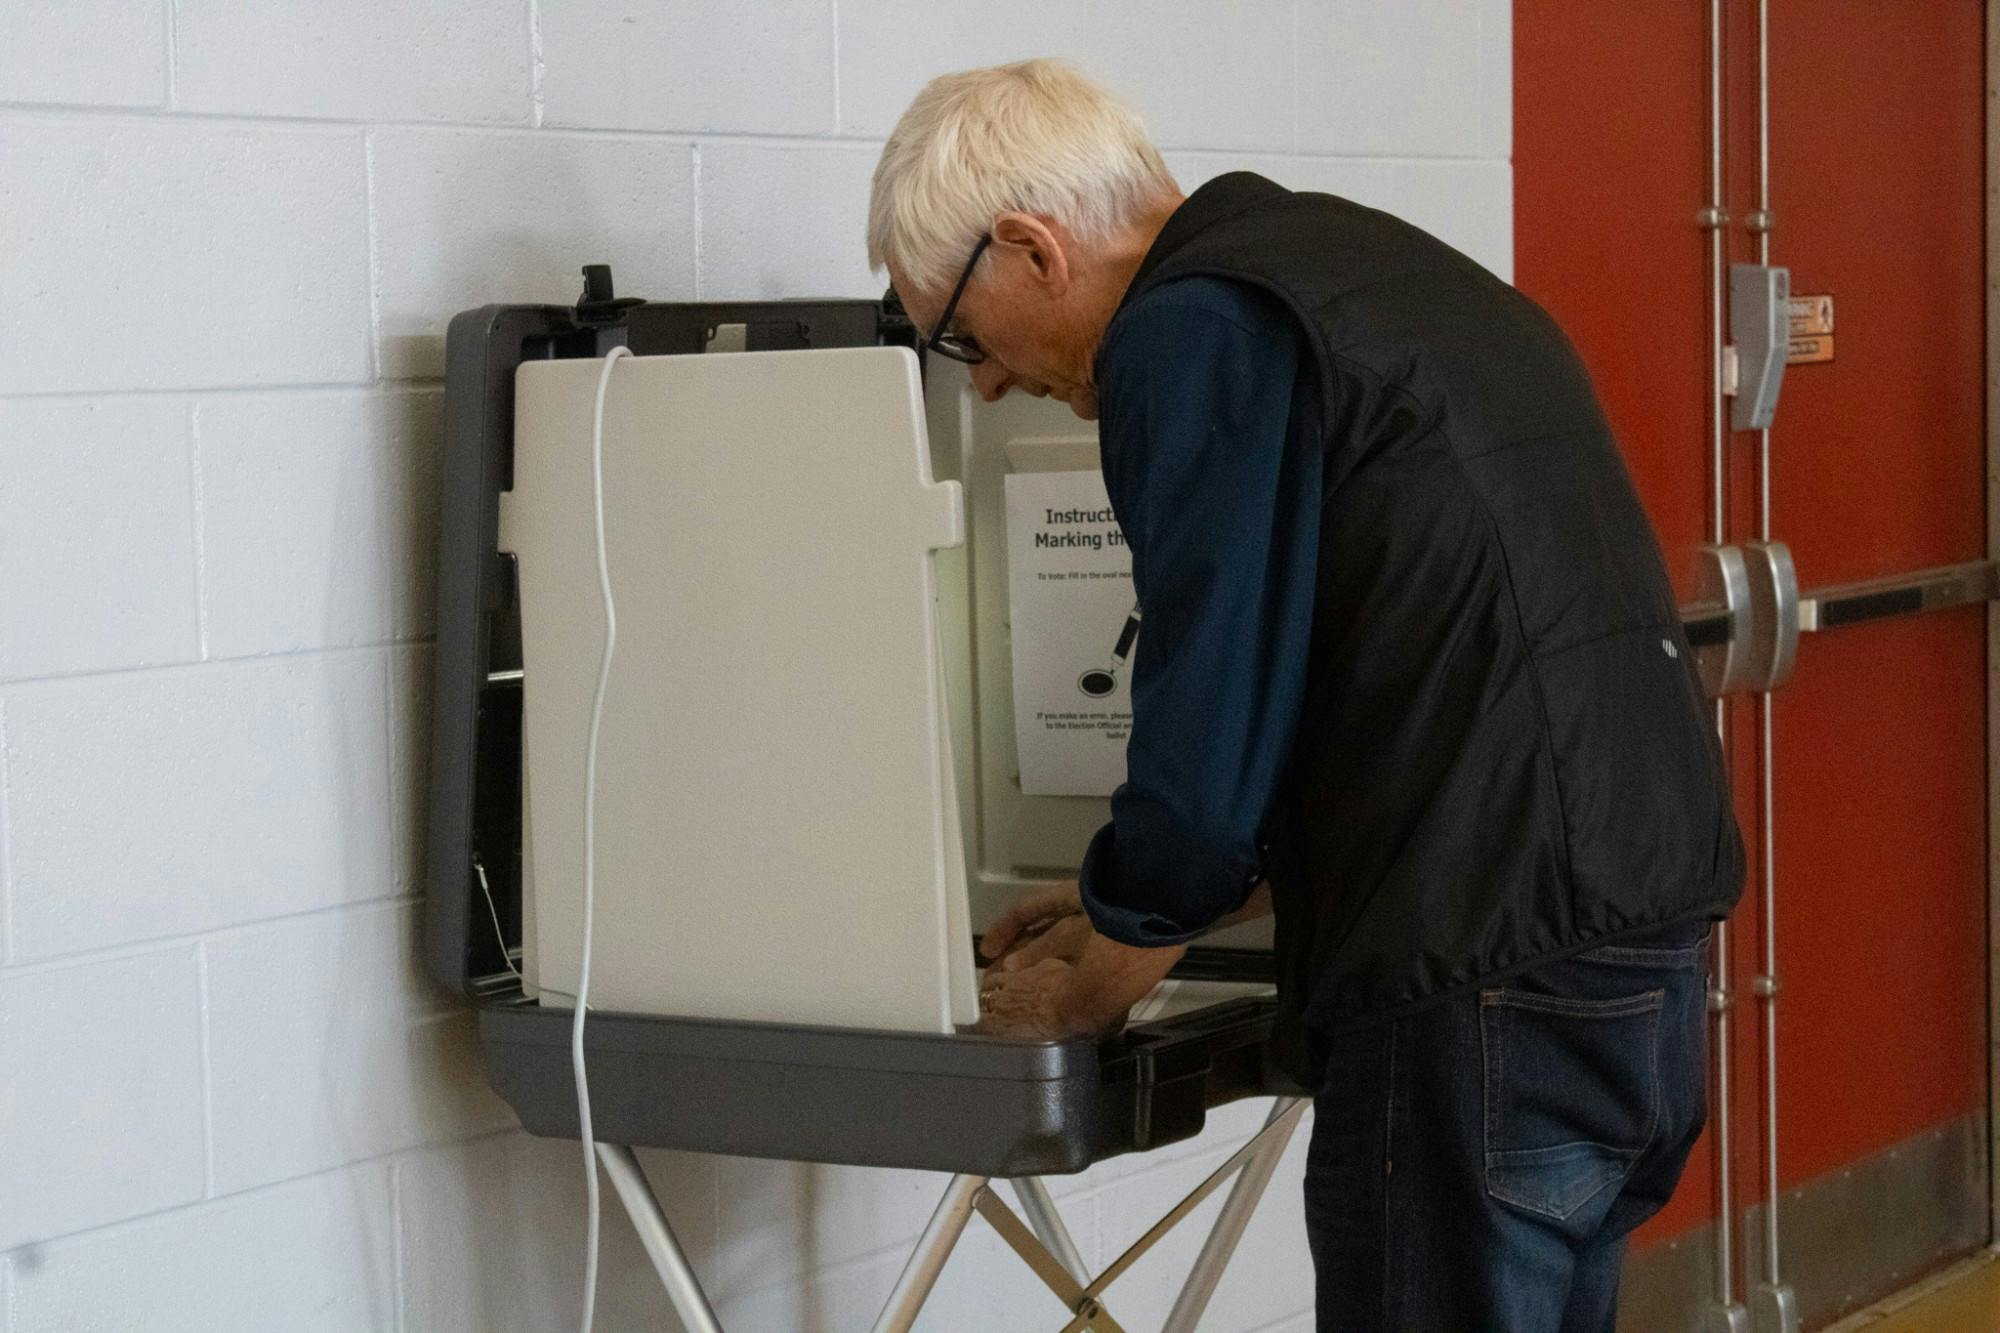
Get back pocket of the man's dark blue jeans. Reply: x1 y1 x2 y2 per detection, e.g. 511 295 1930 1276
1480 989 1666 1221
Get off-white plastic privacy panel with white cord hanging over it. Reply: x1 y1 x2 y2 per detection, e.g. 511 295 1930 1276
500 348 978 1031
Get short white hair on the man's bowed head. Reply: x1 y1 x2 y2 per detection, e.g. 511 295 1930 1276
868 60 1178 292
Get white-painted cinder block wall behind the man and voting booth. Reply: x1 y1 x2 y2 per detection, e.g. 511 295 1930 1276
0 0 1512 1333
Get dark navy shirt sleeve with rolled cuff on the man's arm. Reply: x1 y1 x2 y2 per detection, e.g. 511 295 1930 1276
1080 278 1320 945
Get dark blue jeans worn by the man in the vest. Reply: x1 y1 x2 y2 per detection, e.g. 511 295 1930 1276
1306 921 1708 1333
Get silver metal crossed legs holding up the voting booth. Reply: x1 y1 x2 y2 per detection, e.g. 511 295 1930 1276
598 1097 1308 1333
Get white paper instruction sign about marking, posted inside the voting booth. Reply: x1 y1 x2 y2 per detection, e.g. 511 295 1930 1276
1006 470 1138 797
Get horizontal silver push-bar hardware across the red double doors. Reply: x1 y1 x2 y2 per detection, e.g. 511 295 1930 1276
1680 542 2000 699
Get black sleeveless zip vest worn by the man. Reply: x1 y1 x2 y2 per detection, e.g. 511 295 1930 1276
1124 172 1742 1079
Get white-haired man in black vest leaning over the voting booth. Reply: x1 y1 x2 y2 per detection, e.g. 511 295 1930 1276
868 60 1742 1333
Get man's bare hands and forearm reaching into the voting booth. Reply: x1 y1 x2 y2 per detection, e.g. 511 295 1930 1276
978 885 1186 1041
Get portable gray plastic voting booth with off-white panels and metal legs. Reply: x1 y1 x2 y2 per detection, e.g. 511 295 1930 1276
424 268 1306 1331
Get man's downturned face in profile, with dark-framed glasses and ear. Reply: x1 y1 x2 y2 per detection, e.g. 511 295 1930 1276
888 214 1098 420
